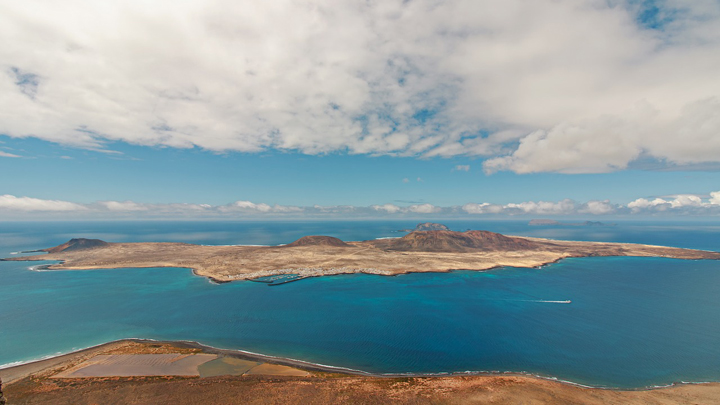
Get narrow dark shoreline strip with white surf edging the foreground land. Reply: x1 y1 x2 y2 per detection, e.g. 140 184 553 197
0 338 720 392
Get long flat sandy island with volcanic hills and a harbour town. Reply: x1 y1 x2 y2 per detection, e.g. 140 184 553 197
2 230 720 285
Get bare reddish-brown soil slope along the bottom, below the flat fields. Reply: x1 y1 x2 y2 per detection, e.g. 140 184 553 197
5 376 720 405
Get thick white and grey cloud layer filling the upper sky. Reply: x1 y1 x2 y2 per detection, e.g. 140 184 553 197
0 0 720 173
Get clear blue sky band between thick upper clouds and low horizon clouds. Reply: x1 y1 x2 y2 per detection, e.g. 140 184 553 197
0 136 720 218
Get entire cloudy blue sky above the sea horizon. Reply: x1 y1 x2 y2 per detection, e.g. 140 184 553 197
0 0 720 220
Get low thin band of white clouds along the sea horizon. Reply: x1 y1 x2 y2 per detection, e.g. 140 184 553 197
5 191 720 219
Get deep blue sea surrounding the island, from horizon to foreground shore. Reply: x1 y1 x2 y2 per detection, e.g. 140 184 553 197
0 220 720 388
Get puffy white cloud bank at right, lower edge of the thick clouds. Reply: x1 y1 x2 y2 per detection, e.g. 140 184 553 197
483 97 720 173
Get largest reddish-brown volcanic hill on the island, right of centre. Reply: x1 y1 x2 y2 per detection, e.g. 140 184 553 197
373 231 542 252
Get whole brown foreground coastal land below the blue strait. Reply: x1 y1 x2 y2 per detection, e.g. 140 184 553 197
0 339 720 405
